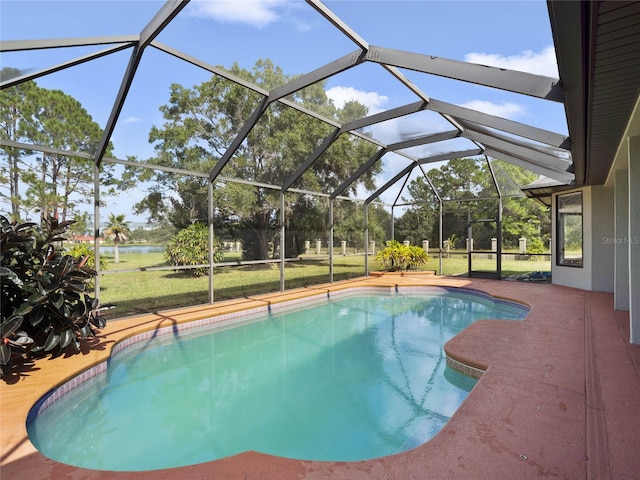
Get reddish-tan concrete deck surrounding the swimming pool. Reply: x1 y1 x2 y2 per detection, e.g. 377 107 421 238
0 274 640 480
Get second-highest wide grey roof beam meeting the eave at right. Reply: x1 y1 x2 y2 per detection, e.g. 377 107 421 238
425 98 571 150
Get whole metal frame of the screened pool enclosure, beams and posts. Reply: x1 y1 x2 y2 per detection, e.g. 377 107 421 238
0 0 575 301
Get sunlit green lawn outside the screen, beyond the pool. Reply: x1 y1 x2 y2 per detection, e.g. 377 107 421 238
100 253 550 318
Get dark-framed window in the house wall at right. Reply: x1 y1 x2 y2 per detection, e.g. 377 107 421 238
556 192 582 267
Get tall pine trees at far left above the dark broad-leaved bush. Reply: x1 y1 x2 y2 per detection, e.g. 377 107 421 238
0 67 130 231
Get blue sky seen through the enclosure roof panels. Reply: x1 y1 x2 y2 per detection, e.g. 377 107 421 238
0 0 566 219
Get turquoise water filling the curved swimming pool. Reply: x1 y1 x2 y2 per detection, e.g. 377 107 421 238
28 286 527 471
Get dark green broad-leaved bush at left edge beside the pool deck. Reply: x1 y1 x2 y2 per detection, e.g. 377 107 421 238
0 215 106 376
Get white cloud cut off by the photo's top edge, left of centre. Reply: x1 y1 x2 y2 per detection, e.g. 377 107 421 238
189 0 289 28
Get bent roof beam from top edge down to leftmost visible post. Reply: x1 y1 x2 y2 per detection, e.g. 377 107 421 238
95 0 189 166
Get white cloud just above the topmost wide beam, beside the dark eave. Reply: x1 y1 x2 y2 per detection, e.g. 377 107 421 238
465 46 558 78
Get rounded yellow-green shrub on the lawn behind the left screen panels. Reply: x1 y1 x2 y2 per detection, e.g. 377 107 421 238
164 223 224 277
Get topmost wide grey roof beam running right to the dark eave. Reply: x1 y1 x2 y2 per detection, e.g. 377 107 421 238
366 46 564 102
